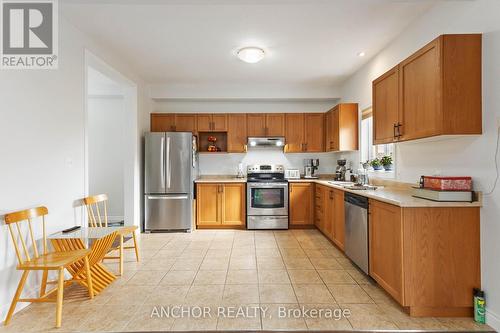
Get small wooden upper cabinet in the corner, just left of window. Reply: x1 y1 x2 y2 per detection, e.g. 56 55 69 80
325 103 359 151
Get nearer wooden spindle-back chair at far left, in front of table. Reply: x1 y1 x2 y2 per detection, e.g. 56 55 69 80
5 207 94 327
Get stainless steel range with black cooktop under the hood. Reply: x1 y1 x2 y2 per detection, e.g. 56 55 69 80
247 165 288 229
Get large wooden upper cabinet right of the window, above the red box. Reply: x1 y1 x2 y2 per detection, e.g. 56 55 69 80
373 34 482 143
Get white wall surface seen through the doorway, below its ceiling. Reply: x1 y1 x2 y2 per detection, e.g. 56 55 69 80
87 96 126 221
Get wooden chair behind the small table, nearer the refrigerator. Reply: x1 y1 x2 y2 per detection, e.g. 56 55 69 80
83 194 139 275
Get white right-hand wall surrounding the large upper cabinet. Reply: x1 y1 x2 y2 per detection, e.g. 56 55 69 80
341 0 500 329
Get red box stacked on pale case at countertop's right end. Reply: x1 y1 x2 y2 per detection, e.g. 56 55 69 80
413 176 474 202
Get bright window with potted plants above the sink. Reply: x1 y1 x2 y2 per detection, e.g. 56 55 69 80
360 108 394 174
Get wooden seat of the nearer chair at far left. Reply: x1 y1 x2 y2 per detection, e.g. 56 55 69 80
17 249 90 270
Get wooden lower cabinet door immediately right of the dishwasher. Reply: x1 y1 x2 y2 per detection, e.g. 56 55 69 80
368 199 404 304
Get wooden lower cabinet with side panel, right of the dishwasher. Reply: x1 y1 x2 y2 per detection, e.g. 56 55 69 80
369 199 481 317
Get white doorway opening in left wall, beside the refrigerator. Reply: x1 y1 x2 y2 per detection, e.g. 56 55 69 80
85 51 140 226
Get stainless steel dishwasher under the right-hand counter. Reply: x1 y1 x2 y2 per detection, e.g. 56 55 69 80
344 192 368 274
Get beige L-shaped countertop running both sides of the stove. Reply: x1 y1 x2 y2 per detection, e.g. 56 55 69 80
195 175 482 207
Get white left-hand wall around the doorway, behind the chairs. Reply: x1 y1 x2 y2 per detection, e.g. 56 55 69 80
0 18 149 320
